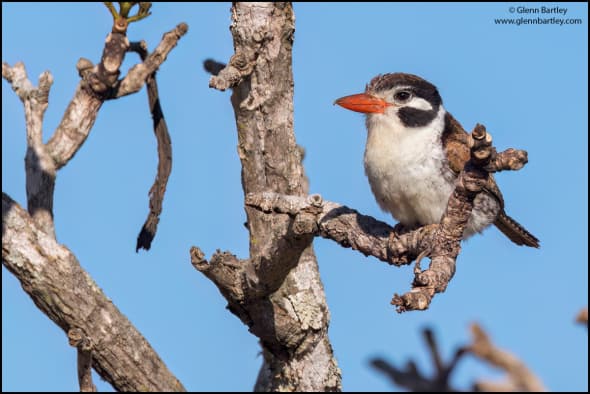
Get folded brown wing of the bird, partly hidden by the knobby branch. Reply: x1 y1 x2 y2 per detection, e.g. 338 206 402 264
442 112 504 209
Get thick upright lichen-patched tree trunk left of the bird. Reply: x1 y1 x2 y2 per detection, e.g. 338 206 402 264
204 3 341 391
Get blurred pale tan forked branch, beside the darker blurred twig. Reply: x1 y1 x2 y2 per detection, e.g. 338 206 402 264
466 323 547 392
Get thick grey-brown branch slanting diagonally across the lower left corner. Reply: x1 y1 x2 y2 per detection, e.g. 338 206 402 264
2 193 184 391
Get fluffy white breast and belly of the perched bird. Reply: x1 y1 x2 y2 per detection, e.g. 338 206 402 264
365 106 454 226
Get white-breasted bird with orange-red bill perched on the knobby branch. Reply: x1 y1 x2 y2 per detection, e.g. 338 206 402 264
335 72 540 248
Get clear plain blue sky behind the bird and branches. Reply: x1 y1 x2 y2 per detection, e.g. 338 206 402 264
2 3 588 391
